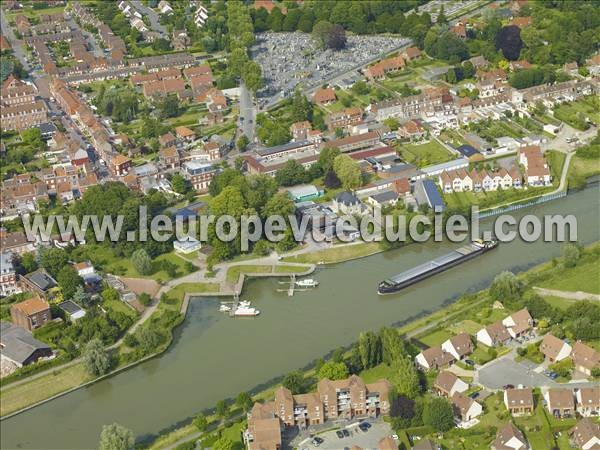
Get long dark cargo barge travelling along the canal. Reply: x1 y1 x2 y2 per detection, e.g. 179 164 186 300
377 240 498 295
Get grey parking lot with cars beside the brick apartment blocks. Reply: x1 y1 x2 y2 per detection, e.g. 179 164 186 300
292 420 393 450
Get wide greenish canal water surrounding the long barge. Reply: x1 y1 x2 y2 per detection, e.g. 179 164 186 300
1 185 600 449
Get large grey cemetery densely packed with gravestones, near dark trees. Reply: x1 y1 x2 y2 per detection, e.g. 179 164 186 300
251 32 410 107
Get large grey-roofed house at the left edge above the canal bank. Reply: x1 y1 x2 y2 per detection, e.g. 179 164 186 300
0 322 53 371
